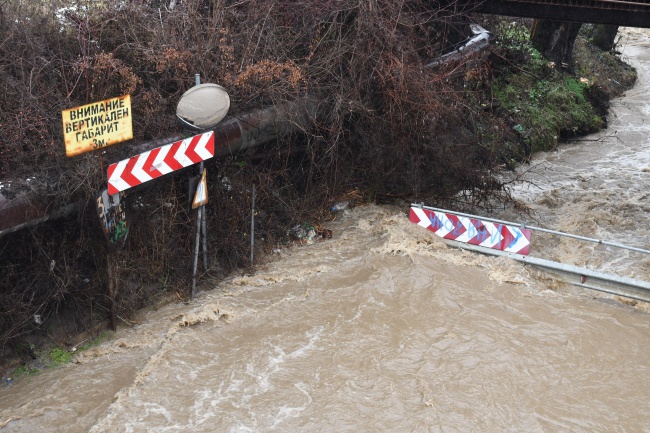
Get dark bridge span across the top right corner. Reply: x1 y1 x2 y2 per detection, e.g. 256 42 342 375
466 0 650 28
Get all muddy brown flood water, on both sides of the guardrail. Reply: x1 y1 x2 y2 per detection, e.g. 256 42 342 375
0 31 650 433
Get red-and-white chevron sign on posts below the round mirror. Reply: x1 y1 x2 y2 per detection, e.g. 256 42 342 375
108 131 214 195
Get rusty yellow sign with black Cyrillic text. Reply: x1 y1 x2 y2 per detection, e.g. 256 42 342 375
61 95 133 156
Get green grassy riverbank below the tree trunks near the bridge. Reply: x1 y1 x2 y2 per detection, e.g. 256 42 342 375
476 21 636 165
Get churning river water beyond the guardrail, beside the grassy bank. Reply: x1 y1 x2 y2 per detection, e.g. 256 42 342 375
492 29 650 281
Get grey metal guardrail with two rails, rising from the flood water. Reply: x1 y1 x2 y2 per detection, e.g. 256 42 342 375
411 204 650 302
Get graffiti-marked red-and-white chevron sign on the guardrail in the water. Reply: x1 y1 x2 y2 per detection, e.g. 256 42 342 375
410 207 532 255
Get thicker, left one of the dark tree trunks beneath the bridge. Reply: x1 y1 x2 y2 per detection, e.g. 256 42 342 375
531 20 582 72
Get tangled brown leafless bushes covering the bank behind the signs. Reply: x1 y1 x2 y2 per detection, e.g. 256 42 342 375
0 0 628 364
